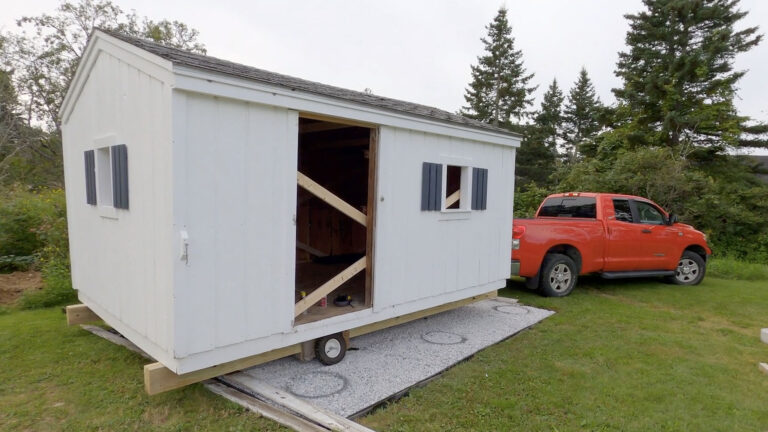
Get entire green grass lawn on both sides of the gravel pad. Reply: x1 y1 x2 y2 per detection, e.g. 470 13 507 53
0 277 768 432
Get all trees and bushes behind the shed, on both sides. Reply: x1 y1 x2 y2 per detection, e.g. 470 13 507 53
0 0 768 267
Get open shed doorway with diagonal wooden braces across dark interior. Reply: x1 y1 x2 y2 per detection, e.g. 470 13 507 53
294 115 378 325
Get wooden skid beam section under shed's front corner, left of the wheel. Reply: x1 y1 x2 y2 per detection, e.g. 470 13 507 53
144 344 301 395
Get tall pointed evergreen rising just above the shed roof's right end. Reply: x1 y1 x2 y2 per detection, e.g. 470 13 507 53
462 8 536 126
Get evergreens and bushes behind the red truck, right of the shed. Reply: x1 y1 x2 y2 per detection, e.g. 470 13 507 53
460 0 768 262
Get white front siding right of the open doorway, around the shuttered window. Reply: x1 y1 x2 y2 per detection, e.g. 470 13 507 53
373 127 515 311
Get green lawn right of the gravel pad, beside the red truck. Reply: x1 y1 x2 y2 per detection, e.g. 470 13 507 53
362 278 768 432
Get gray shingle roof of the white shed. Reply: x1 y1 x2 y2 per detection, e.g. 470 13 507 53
97 29 519 137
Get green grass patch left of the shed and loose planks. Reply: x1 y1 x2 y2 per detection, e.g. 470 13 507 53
0 308 285 431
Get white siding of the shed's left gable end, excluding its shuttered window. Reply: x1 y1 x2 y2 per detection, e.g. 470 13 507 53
62 40 173 362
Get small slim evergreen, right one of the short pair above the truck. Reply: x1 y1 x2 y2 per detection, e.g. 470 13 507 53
563 68 603 162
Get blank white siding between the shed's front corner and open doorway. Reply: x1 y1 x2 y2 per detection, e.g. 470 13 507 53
173 91 298 358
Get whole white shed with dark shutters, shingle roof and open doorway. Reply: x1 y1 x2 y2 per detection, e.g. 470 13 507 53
61 30 520 388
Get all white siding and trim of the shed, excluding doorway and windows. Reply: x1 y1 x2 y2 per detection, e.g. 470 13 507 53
62 32 519 373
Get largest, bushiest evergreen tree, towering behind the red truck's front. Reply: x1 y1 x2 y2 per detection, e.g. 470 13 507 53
613 0 764 156
